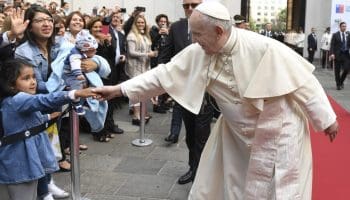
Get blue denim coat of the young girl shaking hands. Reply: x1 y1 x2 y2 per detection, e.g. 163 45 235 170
0 91 71 184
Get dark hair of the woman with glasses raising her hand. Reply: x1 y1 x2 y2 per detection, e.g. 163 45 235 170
24 4 55 47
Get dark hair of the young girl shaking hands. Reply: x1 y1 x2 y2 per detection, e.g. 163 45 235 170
0 58 33 99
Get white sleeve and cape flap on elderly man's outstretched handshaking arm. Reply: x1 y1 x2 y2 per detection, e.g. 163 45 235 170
121 44 208 114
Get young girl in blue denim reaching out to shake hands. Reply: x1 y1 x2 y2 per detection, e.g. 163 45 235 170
0 59 93 200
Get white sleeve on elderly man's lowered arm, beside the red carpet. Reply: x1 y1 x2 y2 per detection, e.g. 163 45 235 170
291 77 337 131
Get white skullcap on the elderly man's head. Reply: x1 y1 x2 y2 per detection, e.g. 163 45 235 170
195 1 231 20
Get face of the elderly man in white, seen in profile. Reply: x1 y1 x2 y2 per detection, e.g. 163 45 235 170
190 10 222 55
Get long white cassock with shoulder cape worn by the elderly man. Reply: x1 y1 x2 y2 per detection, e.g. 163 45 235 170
122 28 336 200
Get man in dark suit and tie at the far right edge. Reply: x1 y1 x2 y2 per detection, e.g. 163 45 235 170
329 22 350 90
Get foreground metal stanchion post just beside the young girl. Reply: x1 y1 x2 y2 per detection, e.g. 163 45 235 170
69 105 88 200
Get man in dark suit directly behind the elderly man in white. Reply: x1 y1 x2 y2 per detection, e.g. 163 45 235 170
158 0 213 184
